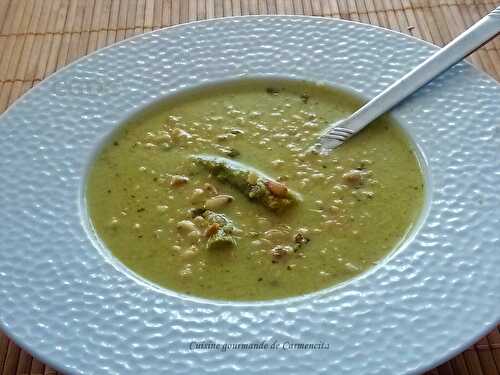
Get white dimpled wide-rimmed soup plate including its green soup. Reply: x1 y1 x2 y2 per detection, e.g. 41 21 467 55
0 17 500 374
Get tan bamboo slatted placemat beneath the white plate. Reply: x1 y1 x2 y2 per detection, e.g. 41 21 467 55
0 0 500 375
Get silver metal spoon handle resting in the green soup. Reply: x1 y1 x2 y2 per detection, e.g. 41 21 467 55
317 7 500 152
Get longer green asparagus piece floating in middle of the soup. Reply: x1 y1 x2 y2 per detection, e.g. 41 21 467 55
193 155 301 212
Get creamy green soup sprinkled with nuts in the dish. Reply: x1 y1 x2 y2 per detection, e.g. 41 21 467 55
86 80 423 300
